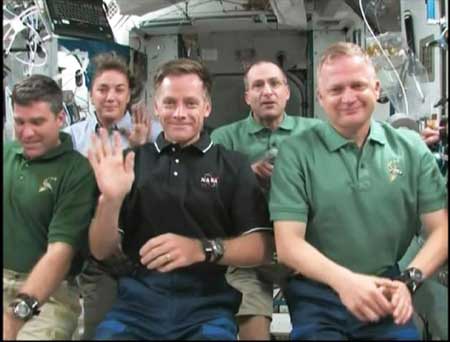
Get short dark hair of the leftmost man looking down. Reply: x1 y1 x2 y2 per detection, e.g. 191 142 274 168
11 74 63 115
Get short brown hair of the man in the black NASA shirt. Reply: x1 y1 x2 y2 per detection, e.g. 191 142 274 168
153 58 212 101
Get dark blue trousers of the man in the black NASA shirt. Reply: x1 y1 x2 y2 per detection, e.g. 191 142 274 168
95 271 241 340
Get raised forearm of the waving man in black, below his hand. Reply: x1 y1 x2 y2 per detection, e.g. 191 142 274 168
89 195 123 260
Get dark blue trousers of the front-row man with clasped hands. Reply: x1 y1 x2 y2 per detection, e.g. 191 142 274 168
283 278 420 340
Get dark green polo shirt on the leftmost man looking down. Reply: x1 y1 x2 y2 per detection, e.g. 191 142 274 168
3 132 97 274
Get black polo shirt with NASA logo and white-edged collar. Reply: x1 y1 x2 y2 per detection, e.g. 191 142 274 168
119 132 272 270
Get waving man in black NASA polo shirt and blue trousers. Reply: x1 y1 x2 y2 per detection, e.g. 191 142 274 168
88 59 273 340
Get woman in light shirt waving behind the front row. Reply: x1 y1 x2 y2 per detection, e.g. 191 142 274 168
64 53 161 339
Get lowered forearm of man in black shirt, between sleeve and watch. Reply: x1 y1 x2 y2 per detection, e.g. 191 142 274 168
219 231 274 267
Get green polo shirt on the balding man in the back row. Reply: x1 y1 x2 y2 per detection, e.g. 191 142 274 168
211 113 320 163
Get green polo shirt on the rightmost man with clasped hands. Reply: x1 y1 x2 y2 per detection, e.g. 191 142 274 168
269 121 446 274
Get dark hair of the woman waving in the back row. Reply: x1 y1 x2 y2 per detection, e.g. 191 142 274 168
91 52 143 105
